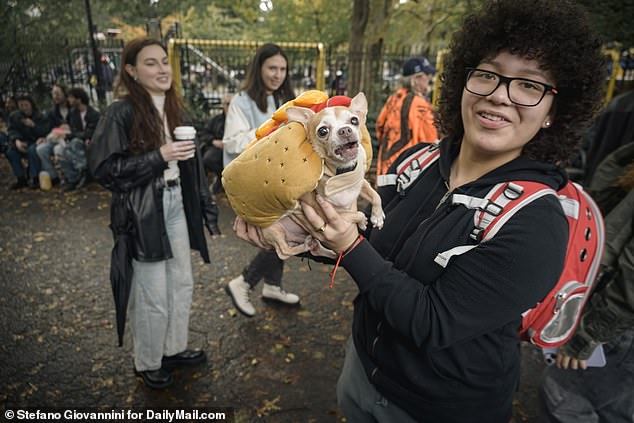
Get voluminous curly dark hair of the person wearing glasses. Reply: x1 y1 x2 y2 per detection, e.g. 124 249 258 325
437 0 607 166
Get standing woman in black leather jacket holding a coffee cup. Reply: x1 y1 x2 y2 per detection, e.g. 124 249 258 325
88 38 220 389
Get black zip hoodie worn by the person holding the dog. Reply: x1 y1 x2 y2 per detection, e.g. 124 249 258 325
341 140 568 423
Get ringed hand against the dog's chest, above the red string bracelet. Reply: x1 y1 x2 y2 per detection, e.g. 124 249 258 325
301 195 359 253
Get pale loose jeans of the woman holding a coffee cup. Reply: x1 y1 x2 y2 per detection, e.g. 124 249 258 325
128 186 194 371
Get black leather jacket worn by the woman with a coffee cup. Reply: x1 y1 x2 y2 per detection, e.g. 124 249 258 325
88 99 220 263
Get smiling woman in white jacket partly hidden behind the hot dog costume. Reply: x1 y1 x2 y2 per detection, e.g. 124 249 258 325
222 44 299 317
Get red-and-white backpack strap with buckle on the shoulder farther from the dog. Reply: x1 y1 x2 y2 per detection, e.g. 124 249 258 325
434 181 557 267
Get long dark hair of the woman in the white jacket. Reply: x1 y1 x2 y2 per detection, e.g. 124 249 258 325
243 43 295 112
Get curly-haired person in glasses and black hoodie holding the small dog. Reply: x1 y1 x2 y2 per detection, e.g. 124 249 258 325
239 0 605 423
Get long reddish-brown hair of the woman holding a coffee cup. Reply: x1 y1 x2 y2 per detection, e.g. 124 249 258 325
114 37 183 153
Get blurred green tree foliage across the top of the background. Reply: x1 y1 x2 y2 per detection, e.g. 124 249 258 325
0 0 634 103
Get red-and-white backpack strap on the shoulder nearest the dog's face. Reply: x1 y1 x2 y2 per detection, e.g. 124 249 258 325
377 140 440 195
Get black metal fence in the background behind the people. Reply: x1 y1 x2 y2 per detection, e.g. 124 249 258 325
0 39 634 120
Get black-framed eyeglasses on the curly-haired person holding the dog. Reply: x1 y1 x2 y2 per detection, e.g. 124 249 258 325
465 68 558 107
